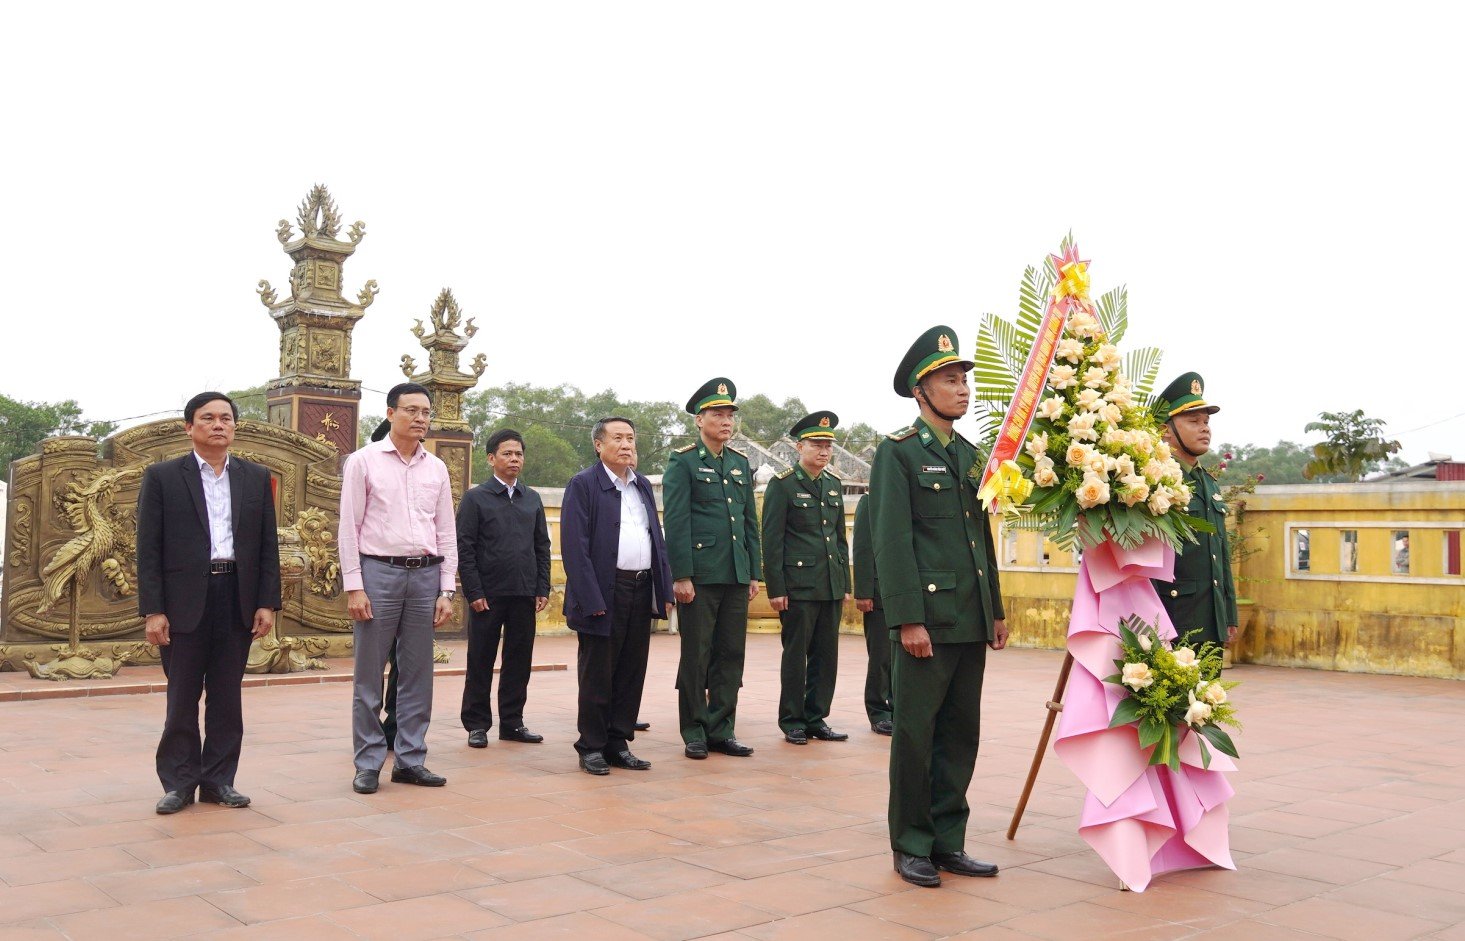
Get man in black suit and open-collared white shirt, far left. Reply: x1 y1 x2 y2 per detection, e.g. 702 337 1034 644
138 391 280 813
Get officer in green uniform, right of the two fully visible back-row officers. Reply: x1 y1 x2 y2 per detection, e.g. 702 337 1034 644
763 412 850 745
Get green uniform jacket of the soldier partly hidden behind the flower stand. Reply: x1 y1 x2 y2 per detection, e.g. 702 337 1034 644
1154 465 1238 643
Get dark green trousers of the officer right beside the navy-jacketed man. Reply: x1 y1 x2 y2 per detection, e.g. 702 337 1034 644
677 582 747 742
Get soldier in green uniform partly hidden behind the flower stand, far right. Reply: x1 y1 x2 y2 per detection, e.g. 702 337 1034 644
1154 372 1238 643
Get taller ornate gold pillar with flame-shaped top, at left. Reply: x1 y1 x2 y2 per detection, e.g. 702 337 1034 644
258 186 377 459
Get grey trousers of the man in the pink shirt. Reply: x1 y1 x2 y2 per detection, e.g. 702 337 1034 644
352 558 440 771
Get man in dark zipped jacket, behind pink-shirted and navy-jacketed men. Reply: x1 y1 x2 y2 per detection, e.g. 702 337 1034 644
457 428 549 748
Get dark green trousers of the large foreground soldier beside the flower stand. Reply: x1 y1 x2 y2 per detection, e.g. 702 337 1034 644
891 642 987 856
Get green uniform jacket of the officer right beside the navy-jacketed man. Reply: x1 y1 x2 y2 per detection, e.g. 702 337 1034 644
661 441 763 585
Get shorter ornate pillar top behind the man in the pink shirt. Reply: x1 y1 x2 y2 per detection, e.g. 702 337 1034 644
401 287 488 504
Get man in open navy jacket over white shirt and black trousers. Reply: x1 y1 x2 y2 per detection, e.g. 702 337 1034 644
560 418 671 774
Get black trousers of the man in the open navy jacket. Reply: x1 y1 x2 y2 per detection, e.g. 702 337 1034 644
574 576 652 755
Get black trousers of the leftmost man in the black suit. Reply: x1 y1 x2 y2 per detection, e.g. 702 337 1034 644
157 575 253 794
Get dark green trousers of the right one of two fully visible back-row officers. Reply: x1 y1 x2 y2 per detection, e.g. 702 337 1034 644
778 601 844 731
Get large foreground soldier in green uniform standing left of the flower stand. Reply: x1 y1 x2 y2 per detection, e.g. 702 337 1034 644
870 327 1008 885
